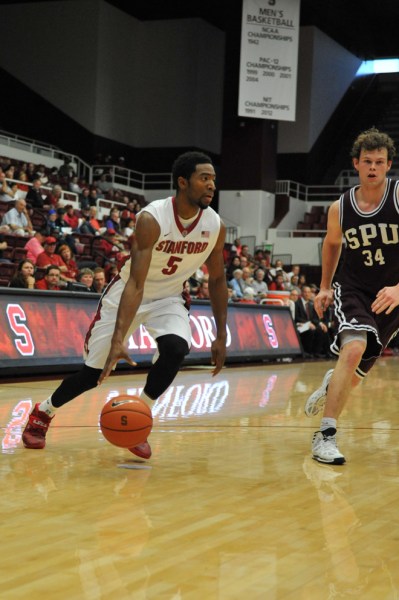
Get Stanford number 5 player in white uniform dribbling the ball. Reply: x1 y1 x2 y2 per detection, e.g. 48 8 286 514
22 152 228 458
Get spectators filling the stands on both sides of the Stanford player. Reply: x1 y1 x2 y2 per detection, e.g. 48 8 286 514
0 157 340 357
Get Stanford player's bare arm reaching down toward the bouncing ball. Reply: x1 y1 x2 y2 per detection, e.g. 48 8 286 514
98 211 160 385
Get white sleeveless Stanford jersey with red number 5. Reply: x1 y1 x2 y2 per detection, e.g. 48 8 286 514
120 197 221 304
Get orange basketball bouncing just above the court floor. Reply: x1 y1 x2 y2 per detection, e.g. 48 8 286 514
100 395 152 448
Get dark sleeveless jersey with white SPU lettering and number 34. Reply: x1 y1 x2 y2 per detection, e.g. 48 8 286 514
337 179 399 297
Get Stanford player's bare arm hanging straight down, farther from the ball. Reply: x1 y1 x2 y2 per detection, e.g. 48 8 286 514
206 223 228 375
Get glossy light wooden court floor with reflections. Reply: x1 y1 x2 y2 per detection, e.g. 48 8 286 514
0 357 399 600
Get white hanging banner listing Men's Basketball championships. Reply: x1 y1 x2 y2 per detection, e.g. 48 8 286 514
238 0 300 121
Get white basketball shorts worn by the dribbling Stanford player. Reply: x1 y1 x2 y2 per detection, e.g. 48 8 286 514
83 279 191 369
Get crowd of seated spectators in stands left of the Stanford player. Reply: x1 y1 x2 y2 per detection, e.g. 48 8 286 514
0 157 142 293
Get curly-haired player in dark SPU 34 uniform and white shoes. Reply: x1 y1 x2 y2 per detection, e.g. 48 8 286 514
305 128 399 465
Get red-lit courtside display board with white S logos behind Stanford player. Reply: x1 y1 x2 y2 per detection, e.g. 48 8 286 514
0 288 302 377
